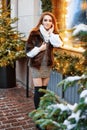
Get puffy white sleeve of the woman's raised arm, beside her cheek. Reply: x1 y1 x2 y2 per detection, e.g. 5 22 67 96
50 33 63 47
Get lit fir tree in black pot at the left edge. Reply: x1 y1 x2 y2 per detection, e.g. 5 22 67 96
0 8 25 88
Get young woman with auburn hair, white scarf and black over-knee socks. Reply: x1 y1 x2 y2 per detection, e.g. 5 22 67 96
26 12 63 109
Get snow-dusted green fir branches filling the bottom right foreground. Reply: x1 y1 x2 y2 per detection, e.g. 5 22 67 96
29 90 87 130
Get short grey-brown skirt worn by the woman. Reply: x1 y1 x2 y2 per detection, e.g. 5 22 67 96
30 66 52 78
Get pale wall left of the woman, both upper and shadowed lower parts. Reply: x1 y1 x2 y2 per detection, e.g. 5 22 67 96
11 0 41 87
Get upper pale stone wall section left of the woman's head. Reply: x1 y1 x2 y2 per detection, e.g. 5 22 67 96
11 0 41 37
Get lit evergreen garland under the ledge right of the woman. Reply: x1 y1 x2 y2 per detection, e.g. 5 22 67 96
53 50 87 76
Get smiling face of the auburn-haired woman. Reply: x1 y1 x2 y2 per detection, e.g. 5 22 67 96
42 15 53 30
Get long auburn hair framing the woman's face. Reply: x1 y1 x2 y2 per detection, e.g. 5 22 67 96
32 12 58 33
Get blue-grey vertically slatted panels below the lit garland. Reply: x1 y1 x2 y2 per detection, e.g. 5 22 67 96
48 71 79 104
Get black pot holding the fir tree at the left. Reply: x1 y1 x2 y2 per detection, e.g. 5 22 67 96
0 65 16 89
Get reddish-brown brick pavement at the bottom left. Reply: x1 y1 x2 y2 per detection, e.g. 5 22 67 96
0 85 36 130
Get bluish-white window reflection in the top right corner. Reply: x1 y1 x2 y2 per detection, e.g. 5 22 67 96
66 0 87 28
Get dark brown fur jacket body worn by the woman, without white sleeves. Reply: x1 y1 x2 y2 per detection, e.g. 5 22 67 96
26 30 53 69
